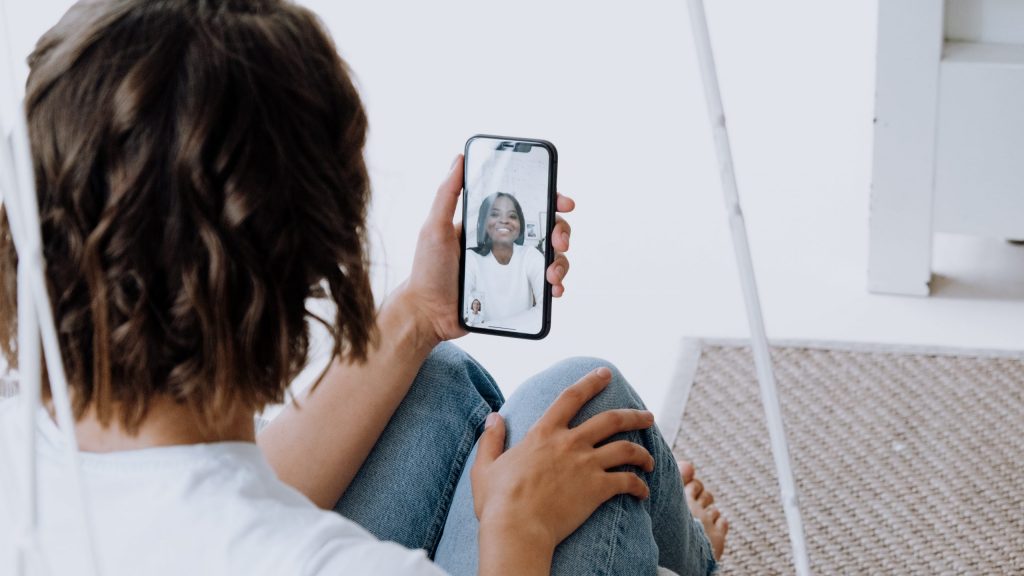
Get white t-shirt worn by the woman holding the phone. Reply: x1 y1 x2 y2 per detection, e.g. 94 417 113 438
0 401 443 576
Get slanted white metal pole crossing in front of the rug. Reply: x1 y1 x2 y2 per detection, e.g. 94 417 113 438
689 0 810 576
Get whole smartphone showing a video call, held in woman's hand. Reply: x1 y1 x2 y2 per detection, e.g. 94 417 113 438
459 134 558 340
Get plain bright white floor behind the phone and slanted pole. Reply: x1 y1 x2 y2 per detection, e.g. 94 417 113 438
4 0 1024 411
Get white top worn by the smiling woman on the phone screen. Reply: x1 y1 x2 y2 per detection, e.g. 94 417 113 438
466 244 544 328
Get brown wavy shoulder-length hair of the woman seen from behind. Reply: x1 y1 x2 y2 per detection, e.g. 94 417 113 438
0 0 375 431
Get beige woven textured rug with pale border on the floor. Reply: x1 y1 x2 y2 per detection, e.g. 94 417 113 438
659 341 1024 575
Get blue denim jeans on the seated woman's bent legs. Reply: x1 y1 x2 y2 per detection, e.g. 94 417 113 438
335 343 715 576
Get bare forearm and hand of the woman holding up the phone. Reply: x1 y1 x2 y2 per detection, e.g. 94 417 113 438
257 155 574 508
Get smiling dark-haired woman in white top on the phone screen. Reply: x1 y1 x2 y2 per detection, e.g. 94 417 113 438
466 192 544 328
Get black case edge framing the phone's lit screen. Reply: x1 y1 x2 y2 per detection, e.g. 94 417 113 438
456 134 558 340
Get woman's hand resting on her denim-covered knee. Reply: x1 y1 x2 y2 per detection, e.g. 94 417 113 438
471 368 654 574
